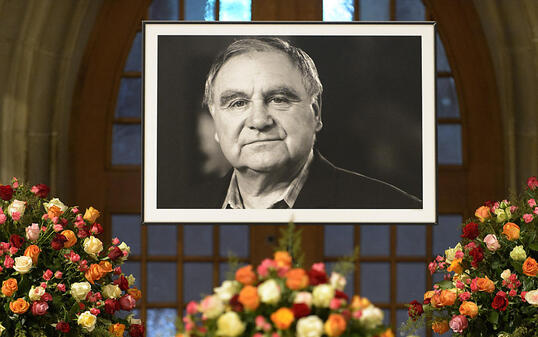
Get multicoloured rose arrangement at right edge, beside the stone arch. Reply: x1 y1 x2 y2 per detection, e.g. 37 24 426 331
403 177 538 337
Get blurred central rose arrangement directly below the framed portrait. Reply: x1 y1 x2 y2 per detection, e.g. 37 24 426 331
176 224 394 337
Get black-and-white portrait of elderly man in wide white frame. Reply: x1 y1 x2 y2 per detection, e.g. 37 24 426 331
142 21 437 224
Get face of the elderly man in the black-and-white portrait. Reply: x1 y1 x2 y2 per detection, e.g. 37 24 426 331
210 51 321 173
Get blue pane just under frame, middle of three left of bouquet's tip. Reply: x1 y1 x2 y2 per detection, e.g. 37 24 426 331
183 225 213 256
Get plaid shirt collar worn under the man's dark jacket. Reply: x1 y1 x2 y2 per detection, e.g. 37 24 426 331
222 151 314 209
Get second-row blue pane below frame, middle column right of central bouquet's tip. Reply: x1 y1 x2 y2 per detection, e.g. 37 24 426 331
360 262 390 302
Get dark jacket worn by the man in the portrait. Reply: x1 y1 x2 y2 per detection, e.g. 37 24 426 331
187 151 422 209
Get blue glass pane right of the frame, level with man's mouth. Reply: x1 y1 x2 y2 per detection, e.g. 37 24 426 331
437 124 463 165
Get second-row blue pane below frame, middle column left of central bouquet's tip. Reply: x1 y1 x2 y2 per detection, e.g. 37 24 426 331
183 263 213 302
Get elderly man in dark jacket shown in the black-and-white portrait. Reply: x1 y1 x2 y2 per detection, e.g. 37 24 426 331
191 38 422 209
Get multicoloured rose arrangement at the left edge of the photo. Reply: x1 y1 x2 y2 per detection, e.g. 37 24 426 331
0 178 144 337
